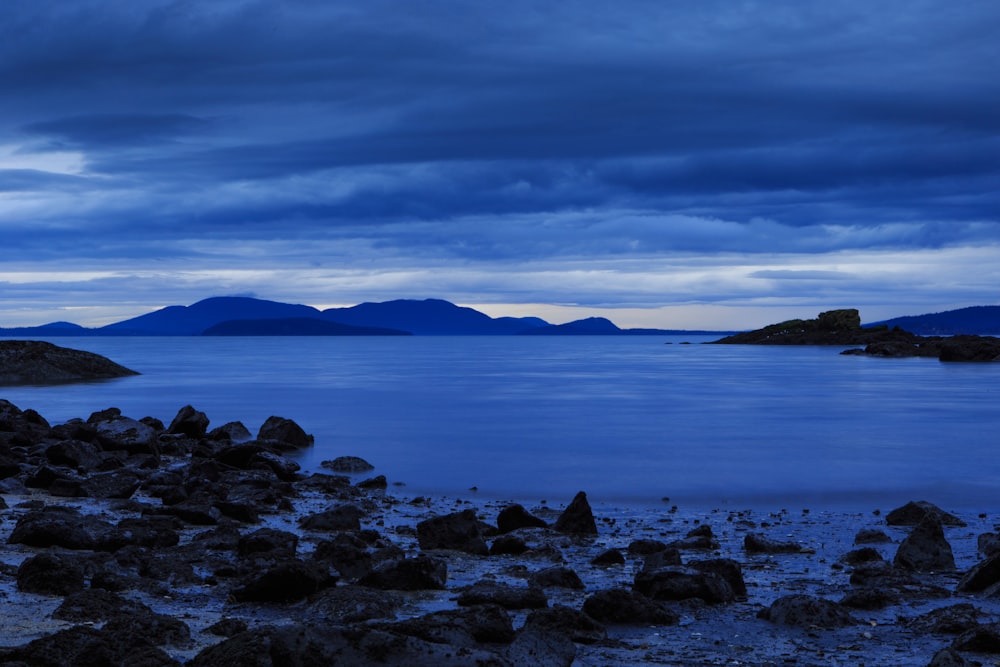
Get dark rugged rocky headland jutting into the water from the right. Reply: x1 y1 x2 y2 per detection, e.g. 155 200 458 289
715 308 1000 361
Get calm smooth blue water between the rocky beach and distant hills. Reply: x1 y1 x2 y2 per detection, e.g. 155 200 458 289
0 336 1000 511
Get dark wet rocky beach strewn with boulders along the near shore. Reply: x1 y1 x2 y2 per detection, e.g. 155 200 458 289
0 401 1000 667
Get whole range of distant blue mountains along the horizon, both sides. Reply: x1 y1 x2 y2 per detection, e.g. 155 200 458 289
0 297 1000 337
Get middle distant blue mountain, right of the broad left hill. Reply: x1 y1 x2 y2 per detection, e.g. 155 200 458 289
323 299 549 336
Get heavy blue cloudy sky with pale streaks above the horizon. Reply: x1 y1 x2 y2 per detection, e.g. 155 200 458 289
0 0 1000 328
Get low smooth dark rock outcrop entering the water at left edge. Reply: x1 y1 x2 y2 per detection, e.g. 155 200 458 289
0 340 138 386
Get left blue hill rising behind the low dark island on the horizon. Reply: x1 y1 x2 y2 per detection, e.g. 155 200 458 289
97 296 319 336
